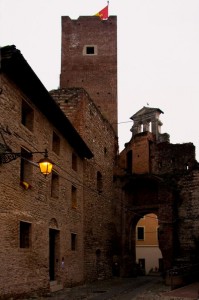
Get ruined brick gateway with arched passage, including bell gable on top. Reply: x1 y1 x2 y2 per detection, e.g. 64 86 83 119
116 107 199 276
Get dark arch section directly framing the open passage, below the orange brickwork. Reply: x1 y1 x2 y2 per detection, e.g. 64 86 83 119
121 175 178 276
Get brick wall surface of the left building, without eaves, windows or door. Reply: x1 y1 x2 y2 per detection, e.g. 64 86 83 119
0 76 87 296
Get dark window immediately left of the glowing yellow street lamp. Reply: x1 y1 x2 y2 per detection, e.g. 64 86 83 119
20 148 33 183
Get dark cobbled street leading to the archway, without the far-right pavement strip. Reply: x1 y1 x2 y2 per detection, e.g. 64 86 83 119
39 276 170 300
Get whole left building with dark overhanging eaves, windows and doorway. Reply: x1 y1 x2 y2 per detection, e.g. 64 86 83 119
0 46 93 298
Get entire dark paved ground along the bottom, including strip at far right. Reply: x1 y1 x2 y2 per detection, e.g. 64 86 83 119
25 276 199 300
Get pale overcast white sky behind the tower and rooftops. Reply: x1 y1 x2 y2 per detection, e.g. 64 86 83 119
0 0 199 161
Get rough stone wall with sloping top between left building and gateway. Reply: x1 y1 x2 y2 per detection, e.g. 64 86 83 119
51 88 117 281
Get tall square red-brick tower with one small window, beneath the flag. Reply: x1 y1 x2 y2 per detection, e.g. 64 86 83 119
60 16 117 134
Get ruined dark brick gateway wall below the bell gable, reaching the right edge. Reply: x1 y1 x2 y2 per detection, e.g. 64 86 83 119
116 114 199 274
